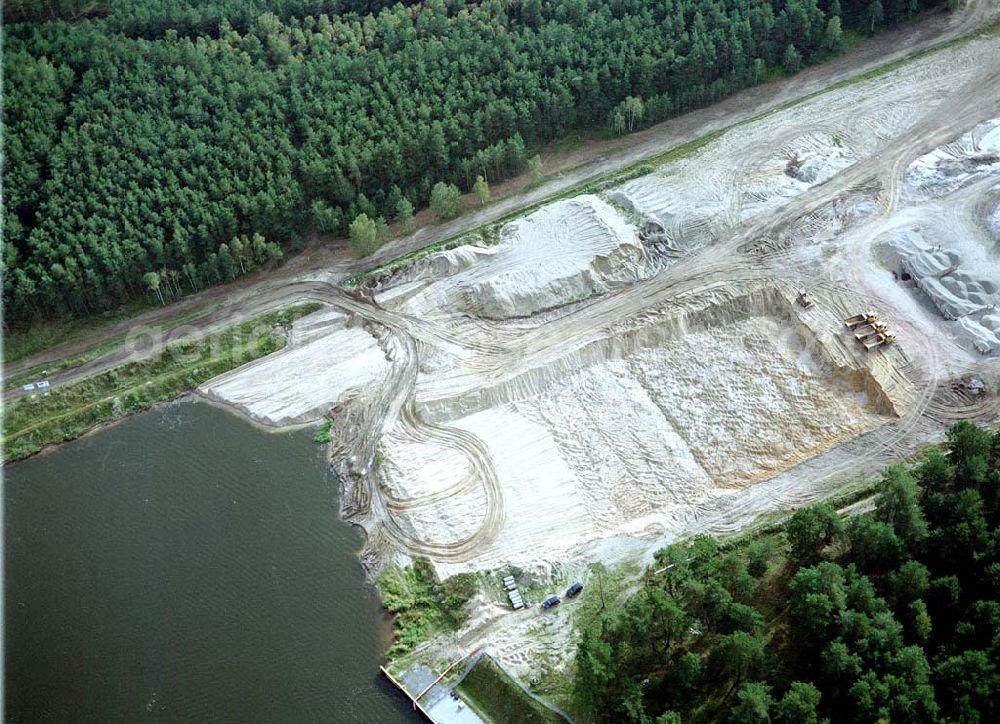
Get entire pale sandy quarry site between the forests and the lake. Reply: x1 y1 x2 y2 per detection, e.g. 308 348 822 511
202 35 1000 672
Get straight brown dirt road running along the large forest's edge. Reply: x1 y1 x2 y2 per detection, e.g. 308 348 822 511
3 0 1000 390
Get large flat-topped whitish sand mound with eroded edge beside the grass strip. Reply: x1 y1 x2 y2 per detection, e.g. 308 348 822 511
378 195 653 319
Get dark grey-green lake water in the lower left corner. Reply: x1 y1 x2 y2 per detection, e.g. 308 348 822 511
4 402 419 722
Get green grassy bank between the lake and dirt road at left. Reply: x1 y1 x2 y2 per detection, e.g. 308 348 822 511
3 303 320 461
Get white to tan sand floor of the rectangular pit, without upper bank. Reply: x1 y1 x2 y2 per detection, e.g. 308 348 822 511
382 302 880 571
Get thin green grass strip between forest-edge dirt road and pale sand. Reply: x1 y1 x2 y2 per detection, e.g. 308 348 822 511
341 21 1000 289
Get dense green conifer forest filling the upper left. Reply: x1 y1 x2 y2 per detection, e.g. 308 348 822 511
3 0 939 325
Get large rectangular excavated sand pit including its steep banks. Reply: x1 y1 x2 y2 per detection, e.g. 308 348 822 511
378 286 895 572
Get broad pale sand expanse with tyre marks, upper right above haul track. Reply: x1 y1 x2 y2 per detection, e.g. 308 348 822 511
611 41 996 268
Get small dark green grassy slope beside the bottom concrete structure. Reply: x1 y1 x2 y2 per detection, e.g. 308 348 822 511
455 656 563 724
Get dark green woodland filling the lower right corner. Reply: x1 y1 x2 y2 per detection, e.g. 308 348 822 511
575 423 1000 724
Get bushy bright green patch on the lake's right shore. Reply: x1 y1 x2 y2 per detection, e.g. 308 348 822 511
377 558 479 659
